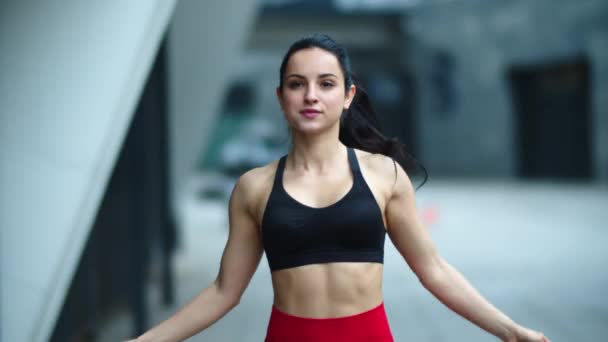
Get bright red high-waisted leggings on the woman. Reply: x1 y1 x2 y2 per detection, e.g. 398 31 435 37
265 303 394 342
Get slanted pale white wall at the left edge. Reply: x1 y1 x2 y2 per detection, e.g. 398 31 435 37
0 0 175 342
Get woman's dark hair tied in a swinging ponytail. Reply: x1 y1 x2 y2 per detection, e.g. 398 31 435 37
279 34 428 188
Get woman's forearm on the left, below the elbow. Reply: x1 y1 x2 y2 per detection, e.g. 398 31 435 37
137 282 238 342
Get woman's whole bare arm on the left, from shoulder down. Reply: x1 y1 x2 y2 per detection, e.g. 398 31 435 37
135 172 263 342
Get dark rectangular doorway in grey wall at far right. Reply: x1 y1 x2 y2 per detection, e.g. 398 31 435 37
508 58 592 180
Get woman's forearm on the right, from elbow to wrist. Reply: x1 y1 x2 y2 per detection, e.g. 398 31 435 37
420 259 517 341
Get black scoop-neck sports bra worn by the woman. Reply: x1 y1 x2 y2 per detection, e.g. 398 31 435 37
262 148 386 271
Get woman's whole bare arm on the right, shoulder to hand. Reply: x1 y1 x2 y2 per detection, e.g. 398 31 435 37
385 162 549 342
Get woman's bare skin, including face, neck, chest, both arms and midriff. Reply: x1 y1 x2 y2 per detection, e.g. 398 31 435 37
131 48 549 342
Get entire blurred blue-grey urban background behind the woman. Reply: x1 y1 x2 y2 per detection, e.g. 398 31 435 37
0 0 608 342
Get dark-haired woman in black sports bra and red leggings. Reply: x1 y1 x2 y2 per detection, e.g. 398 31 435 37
131 35 548 342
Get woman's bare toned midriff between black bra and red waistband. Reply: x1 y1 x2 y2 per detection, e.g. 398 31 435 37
272 262 383 318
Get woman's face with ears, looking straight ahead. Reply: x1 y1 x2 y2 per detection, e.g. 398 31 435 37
277 48 355 133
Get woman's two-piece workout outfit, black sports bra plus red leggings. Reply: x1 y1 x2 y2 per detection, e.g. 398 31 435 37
262 148 393 342
